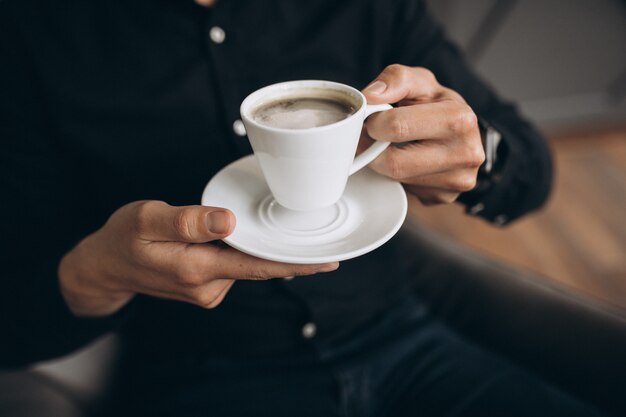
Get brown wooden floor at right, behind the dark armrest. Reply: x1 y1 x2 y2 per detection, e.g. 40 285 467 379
410 127 626 309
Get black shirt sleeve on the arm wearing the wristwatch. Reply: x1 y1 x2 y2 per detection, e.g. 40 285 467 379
387 0 552 224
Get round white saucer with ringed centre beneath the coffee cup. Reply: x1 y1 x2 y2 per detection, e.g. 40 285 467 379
202 155 407 264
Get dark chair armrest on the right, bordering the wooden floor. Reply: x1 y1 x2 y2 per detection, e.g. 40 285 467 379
401 219 626 416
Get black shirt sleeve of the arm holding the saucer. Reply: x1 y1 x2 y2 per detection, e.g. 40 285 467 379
0 2 123 368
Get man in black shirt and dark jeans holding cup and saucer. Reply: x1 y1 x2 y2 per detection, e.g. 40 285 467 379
0 0 594 416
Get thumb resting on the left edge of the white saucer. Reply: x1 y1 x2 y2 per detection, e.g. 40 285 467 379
135 201 235 243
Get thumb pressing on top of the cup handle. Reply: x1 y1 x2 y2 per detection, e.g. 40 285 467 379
363 64 446 104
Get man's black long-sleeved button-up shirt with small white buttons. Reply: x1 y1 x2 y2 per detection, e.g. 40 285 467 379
0 0 551 366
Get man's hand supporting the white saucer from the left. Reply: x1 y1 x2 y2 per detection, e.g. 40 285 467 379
59 201 339 317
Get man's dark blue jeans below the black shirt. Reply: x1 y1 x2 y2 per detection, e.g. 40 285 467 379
125 292 601 417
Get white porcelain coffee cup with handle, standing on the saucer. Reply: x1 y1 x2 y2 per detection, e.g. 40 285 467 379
240 80 391 211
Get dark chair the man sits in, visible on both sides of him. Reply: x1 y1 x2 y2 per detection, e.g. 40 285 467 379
0 219 626 417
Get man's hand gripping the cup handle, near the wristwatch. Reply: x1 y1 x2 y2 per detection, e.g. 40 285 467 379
361 65 485 204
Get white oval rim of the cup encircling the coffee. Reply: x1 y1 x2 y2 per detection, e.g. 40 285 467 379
239 80 367 134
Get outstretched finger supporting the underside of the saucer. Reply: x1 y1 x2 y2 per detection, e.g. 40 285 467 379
197 245 339 280
